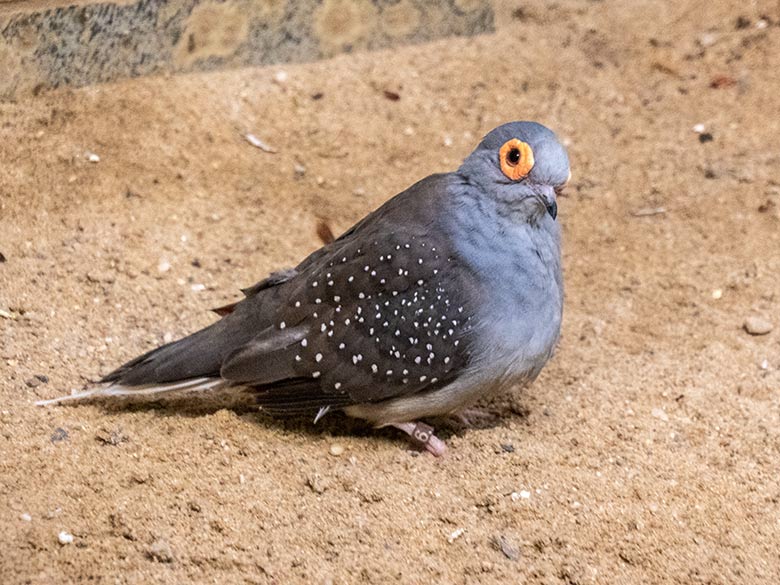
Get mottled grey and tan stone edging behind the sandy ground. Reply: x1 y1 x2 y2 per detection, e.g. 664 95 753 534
0 0 494 99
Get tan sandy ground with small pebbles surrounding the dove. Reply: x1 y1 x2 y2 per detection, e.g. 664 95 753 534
0 0 780 585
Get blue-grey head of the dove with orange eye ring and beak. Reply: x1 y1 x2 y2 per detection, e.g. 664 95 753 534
458 122 571 223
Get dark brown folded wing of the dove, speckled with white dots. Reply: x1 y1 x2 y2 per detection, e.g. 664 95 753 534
220 173 473 404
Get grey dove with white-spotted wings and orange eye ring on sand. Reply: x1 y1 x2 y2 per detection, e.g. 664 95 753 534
39 121 571 456
